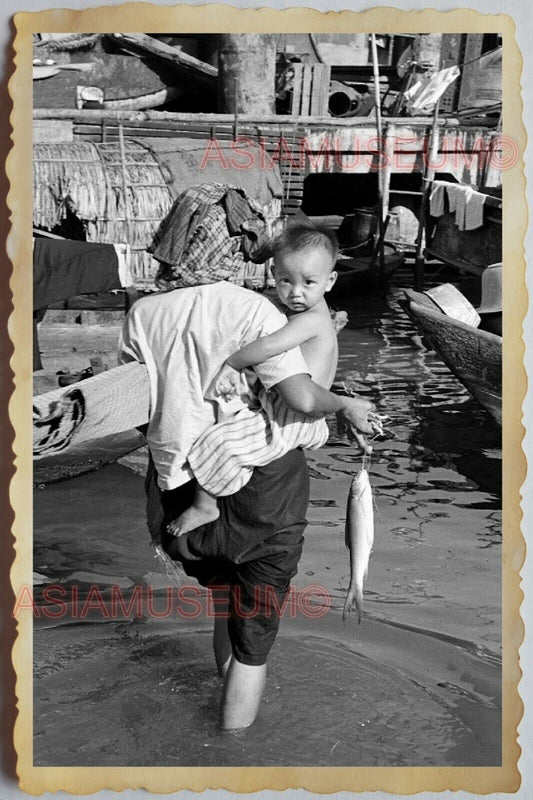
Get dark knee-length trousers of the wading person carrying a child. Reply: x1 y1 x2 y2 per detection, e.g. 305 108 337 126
157 450 309 665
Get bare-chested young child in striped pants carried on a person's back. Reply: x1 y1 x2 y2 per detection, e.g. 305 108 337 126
168 225 338 536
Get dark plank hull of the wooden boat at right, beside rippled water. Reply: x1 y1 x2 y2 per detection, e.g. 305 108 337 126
402 289 502 425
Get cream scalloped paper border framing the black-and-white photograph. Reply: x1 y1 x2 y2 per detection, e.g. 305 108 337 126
6 3 527 794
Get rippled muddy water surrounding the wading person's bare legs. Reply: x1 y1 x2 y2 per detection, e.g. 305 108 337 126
34 276 501 766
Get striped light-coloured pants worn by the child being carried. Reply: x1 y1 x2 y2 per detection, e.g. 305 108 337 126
188 390 329 497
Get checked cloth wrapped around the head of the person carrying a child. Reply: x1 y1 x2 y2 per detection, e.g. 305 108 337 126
148 183 271 291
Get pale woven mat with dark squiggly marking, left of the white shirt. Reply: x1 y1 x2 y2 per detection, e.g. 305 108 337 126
33 362 150 459
